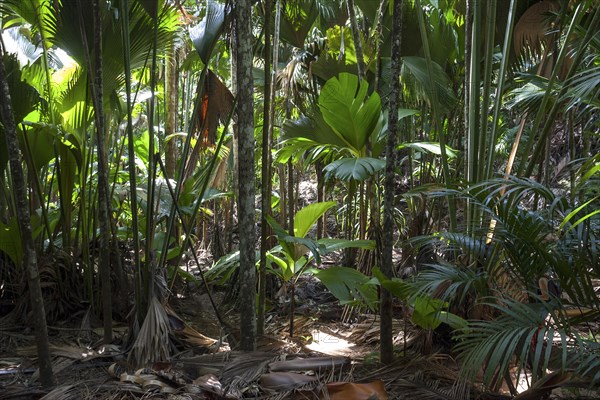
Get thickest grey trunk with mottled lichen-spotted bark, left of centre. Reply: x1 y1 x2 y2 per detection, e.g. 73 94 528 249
235 0 256 351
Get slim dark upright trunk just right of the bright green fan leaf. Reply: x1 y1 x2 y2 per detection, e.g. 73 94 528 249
379 0 402 364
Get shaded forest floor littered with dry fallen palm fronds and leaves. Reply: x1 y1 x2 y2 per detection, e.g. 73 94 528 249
0 277 600 400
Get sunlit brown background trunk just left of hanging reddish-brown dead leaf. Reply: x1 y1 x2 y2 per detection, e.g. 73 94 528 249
165 41 179 178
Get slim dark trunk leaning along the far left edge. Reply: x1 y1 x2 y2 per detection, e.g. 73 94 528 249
0 46 55 387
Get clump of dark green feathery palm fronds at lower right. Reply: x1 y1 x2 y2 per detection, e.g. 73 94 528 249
412 177 600 388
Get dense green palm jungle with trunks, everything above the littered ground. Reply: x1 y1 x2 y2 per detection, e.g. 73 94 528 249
0 0 600 389
